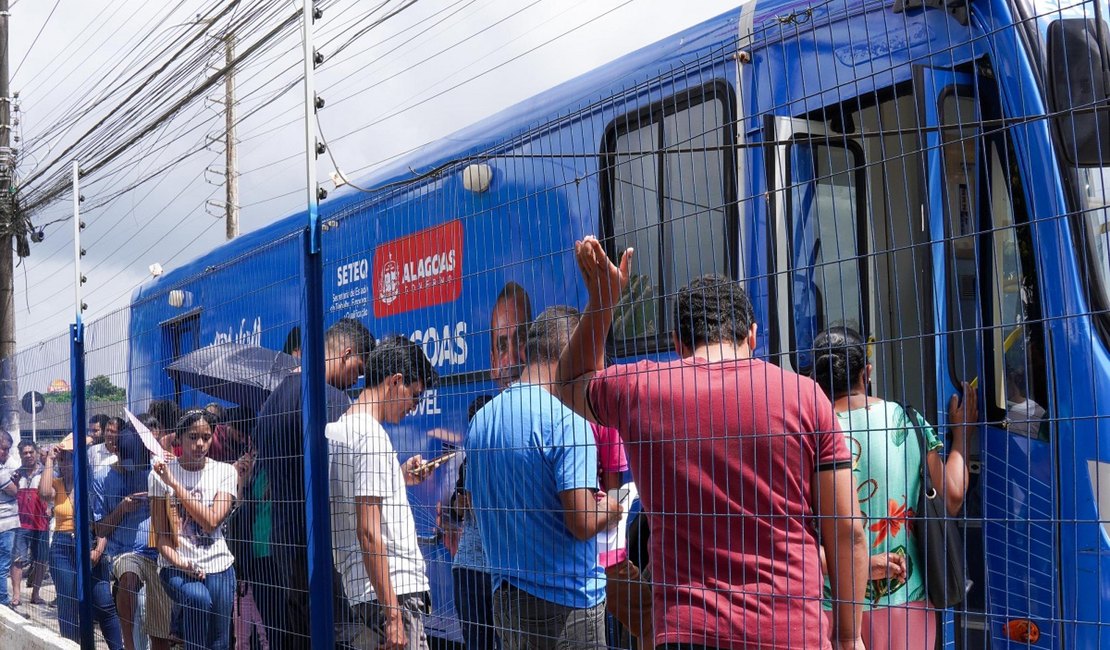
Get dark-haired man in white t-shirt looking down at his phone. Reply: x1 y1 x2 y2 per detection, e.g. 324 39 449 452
326 336 438 650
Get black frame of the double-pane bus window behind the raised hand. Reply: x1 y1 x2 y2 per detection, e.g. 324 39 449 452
598 79 739 357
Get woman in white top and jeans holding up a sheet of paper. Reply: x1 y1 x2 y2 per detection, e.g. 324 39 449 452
150 409 238 650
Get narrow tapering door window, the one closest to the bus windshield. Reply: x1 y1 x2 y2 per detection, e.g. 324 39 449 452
987 145 1048 438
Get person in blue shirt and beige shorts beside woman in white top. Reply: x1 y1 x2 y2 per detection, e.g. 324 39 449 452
92 428 172 650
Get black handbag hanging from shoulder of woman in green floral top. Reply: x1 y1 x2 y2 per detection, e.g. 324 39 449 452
902 406 969 609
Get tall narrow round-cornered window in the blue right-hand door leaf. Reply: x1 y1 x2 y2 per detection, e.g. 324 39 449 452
940 87 979 385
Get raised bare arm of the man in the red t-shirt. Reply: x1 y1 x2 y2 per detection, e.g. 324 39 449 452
555 236 633 422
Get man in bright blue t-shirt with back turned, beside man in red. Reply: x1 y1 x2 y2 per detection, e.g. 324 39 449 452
466 306 620 650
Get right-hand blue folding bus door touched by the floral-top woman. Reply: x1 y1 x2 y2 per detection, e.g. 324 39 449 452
914 67 1058 648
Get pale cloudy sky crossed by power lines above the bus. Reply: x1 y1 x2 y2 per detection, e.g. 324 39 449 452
10 0 737 389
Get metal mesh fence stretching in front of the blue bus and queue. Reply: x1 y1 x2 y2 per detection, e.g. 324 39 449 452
8 2 1110 648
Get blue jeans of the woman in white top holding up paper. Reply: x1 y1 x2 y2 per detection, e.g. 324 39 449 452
159 567 235 650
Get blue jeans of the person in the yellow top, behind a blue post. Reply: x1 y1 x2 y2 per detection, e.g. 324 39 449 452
50 532 123 650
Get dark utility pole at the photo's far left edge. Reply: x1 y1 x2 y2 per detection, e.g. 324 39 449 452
0 0 19 438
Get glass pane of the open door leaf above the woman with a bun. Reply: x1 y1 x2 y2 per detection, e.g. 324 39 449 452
787 140 868 370
